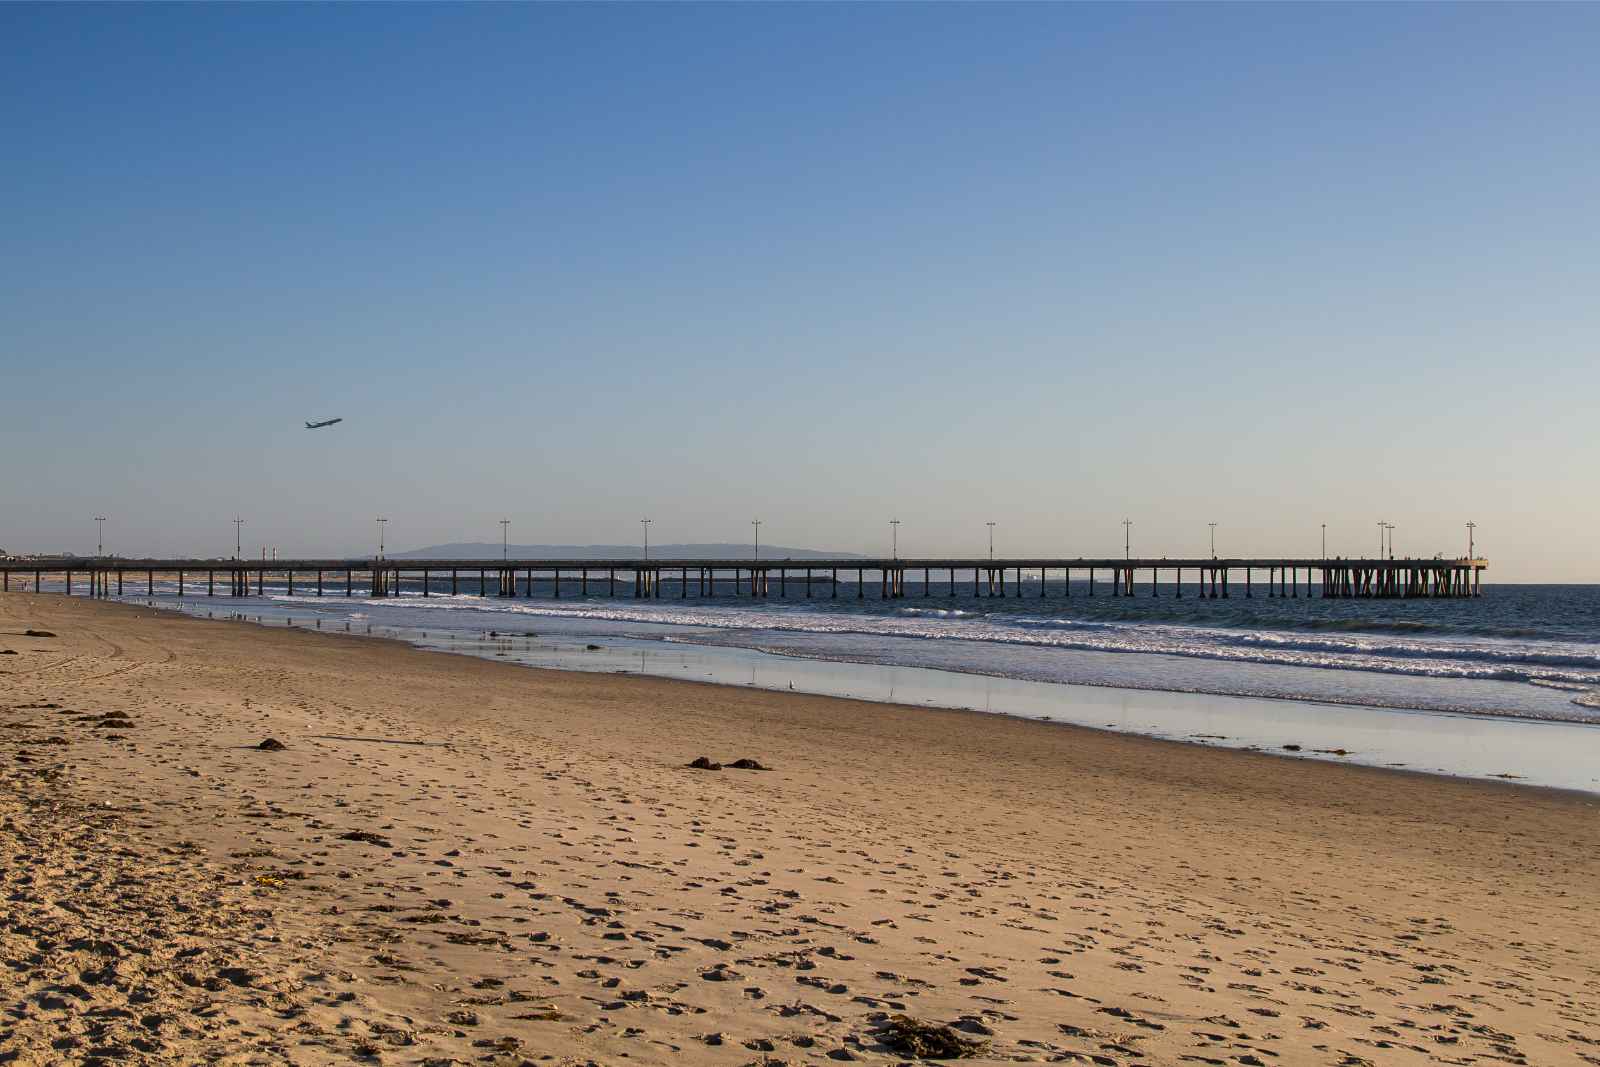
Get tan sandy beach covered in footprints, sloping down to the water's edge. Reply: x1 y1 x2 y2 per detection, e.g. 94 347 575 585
0 593 1600 1065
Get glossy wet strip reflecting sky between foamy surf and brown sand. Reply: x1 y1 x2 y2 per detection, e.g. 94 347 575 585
112 600 1600 793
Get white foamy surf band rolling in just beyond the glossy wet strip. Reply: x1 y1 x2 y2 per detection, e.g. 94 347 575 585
109 590 1600 723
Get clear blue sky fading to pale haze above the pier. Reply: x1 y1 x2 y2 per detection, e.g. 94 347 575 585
0 5 1600 581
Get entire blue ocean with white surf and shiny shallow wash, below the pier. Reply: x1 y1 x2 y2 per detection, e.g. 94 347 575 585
75 574 1600 787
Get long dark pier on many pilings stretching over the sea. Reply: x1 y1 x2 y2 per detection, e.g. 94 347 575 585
0 558 1488 600
